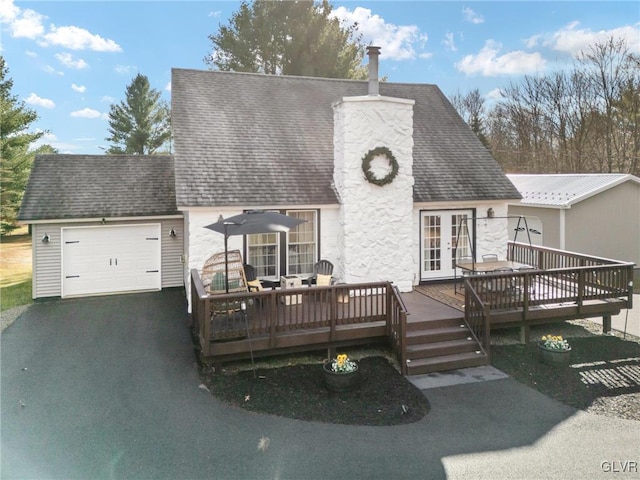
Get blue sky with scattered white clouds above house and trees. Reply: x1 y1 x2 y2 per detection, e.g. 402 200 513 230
0 0 640 154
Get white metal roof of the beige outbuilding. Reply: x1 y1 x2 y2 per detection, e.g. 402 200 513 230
507 173 640 208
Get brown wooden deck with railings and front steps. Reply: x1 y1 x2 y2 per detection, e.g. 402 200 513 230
191 244 633 374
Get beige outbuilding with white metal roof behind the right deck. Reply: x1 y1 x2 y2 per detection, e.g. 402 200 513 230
507 174 640 266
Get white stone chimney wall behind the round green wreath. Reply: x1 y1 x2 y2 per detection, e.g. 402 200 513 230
334 95 416 291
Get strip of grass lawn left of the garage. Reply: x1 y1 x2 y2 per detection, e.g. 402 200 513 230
0 227 32 311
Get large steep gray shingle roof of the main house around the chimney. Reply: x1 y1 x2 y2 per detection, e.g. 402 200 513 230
171 69 520 206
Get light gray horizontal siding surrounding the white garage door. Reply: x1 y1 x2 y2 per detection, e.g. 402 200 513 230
32 217 185 298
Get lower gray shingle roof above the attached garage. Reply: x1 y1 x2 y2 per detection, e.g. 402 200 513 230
18 155 178 221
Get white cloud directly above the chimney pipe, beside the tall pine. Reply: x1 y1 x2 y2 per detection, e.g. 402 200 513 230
331 7 427 60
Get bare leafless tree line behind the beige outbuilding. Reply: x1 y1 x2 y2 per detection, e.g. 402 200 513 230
450 38 640 176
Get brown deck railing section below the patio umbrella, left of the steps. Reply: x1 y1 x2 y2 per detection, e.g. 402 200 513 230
191 269 406 357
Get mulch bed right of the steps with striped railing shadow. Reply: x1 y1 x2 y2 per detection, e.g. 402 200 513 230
491 335 640 420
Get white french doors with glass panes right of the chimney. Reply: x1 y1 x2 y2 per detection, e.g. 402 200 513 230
420 210 474 280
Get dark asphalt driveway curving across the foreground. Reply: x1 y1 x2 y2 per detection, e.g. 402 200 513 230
0 290 640 479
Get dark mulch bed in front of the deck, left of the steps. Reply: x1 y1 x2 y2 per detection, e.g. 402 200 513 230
203 356 429 425
